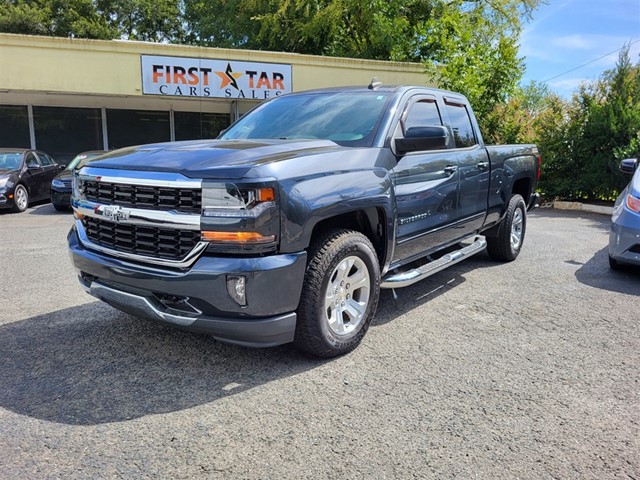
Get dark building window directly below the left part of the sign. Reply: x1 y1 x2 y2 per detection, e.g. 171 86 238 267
107 109 171 149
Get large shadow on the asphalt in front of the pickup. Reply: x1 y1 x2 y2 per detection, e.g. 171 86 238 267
0 302 323 425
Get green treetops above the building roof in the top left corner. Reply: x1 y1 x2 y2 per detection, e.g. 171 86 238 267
0 0 117 39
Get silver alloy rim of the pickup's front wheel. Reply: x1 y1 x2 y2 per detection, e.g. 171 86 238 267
324 256 371 335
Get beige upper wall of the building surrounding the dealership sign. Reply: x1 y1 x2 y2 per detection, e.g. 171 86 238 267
0 34 427 112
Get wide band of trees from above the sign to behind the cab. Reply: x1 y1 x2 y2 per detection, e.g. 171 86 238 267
185 0 539 119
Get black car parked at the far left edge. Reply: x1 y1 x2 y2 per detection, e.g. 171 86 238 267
0 148 64 212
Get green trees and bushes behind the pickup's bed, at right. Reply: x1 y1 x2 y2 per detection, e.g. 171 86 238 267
496 47 640 200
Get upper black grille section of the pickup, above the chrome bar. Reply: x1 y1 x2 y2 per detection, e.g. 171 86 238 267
82 180 202 213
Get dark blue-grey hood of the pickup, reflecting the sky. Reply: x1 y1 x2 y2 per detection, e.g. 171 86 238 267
85 140 346 178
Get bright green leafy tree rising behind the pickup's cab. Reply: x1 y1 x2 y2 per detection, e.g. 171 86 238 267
420 0 539 122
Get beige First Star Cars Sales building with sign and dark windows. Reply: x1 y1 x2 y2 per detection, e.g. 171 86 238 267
0 34 427 163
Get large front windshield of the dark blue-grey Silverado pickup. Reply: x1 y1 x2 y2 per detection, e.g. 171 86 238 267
220 91 389 146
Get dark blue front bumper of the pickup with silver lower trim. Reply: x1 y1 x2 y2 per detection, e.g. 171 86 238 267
68 227 306 347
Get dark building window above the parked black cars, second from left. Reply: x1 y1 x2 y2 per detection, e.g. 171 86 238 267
33 107 104 164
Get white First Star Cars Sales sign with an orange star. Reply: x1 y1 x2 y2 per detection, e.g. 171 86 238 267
141 55 291 100
